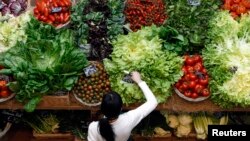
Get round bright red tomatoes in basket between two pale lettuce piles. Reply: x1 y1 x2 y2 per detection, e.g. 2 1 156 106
175 55 210 99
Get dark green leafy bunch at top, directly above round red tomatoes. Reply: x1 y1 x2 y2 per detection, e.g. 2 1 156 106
165 0 221 53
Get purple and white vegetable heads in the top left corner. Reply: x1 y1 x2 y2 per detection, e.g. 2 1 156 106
0 0 28 16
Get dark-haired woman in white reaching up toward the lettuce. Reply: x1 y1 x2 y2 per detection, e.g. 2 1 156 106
88 72 158 141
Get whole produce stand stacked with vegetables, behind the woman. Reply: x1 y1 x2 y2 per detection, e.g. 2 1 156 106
0 0 250 141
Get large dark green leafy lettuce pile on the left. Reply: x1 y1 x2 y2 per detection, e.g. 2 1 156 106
0 19 87 112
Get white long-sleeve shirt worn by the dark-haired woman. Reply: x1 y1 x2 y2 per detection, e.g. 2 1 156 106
88 81 158 141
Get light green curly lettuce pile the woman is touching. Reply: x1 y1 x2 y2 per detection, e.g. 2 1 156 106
104 26 183 104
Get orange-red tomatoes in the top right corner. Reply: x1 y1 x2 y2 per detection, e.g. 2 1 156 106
222 0 250 18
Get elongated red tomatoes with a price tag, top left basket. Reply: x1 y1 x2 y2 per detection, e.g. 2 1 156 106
34 0 71 27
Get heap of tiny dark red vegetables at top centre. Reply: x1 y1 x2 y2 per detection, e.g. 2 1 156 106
124 0 167 31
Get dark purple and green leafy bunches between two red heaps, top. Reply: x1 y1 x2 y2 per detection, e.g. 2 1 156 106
71 0 124 60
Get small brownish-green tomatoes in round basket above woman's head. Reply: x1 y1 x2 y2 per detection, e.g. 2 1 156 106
72 62 110 104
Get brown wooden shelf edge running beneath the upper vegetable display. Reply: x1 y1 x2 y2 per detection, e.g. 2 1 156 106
0 94 250 112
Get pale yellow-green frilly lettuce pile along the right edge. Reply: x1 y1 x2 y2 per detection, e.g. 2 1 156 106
202 11 250 107
